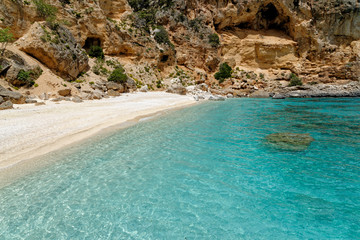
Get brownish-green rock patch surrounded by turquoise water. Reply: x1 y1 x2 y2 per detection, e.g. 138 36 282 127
265 133 314 151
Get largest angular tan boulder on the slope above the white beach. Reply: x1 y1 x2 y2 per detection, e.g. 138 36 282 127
17 22 89 80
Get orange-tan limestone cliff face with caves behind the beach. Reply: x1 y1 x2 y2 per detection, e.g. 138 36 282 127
0 0 360 95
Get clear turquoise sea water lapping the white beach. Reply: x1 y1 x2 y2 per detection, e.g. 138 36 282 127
0 99 360 240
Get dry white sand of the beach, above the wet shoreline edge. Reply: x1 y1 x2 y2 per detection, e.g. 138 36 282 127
0 92 195 174
